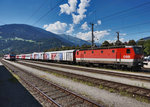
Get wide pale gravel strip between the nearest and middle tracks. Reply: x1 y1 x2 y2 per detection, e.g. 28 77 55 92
3 61 150 107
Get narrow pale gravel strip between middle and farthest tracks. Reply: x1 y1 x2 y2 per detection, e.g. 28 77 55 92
19 62 150 89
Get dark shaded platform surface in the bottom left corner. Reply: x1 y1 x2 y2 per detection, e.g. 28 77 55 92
0 62 42 107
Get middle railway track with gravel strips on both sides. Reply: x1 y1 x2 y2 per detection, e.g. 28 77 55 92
13 59 150 101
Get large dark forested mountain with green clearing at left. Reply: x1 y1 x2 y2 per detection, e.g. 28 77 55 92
0 24 89 54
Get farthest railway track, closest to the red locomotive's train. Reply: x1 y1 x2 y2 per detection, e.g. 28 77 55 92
20 60 150 82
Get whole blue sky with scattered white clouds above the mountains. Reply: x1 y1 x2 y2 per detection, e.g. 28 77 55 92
0 0 150 43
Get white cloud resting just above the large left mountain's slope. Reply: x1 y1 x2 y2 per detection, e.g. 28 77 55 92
43 21 67 34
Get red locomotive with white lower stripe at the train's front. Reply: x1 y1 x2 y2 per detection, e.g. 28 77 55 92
76 46 143 68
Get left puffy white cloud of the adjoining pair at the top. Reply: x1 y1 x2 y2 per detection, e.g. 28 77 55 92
59 0 77 15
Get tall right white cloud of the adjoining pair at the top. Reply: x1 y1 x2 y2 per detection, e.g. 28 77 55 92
72 0 91 24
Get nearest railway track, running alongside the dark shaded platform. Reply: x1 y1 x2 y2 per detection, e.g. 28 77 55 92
2 61 101 107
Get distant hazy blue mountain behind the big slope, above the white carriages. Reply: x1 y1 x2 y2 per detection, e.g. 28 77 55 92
59 34 91 46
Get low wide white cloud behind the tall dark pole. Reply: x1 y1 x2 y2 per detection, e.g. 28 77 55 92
76 30 110 42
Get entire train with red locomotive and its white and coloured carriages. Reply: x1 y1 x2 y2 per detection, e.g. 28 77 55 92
16 46 144 68
